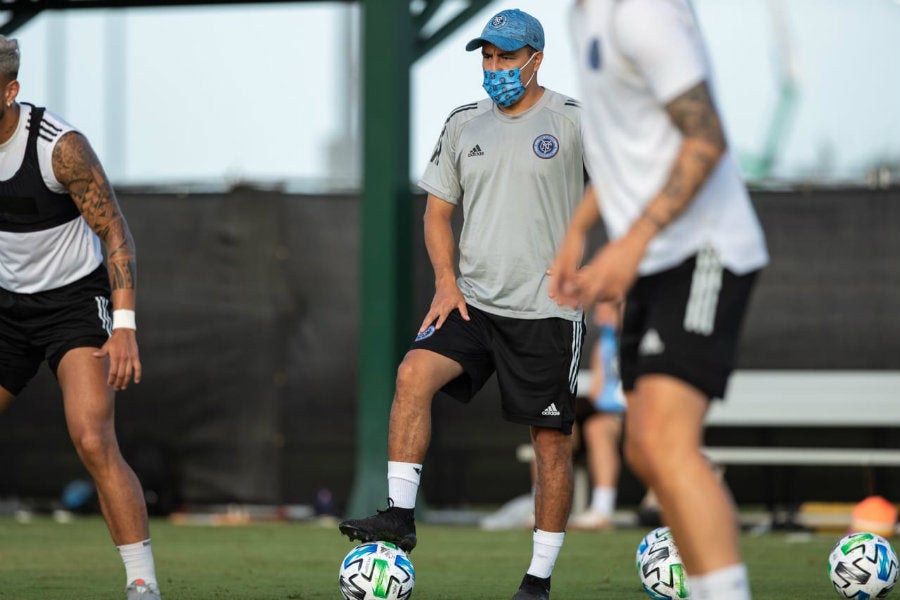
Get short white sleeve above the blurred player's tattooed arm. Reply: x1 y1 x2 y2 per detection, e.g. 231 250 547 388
614 0 709 104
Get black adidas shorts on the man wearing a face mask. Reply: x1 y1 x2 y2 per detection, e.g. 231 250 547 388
410 305 584 434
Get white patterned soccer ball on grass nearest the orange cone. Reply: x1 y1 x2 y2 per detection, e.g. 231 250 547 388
828 532 900 600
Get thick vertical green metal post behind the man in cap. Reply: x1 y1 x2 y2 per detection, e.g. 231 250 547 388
348 0 413 515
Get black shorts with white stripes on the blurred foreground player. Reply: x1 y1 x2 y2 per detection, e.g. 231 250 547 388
619 249 759 398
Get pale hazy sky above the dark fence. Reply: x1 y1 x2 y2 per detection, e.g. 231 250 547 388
8 0 900 188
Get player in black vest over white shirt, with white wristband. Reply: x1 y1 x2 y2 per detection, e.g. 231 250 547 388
0 36 160 600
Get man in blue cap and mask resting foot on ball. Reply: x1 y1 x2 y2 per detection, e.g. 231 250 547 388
340 10 584 600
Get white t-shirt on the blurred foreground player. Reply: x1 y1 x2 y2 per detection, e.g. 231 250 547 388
571 0 768 275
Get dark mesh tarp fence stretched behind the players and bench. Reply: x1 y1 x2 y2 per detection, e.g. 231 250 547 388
0 188 900 510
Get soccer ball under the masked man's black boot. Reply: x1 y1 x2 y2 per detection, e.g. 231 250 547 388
338 542 416 600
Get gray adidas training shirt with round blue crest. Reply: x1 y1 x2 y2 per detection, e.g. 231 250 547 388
419 89 584 321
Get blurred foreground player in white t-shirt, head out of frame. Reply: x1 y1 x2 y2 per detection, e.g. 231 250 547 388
550 0 768 600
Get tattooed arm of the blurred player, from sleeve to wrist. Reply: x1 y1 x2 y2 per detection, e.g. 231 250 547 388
641 82 725 230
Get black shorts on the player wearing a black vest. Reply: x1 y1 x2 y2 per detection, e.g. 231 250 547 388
0 265 112 394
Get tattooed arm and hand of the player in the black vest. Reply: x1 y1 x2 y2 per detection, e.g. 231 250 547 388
52 131 141 390
